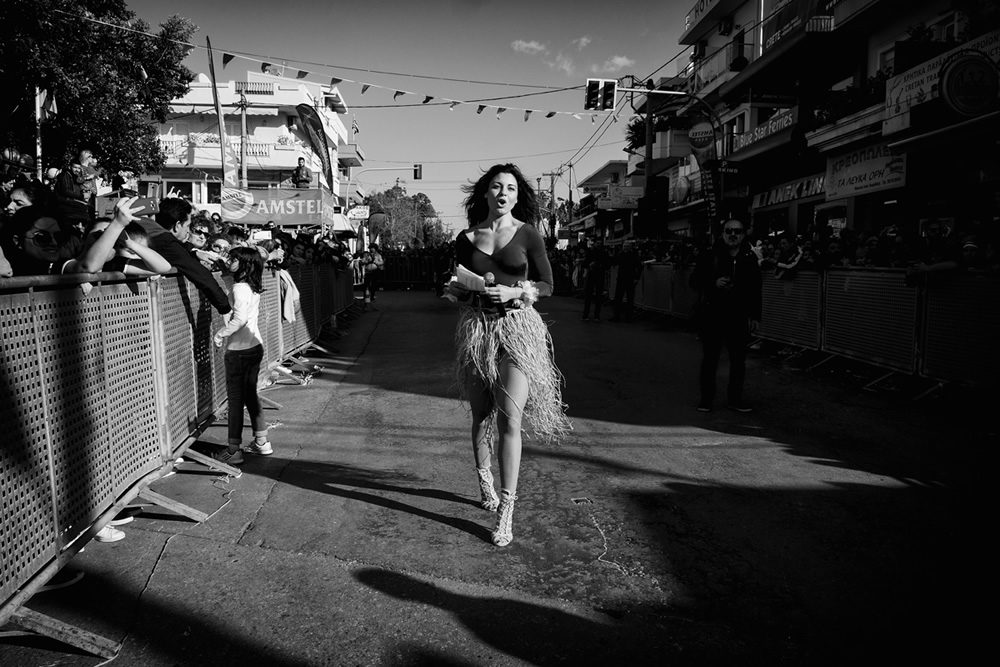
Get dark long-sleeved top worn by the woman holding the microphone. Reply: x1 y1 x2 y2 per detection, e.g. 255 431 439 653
455 224 552 296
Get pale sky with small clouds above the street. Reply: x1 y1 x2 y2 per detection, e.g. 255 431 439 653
128 0 695 228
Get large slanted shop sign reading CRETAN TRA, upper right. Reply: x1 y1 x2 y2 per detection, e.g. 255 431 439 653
882 30 1000 136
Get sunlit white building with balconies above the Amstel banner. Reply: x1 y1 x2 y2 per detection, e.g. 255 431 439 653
146 72 365 224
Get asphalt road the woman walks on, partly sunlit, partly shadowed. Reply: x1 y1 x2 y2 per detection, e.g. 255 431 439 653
0 291 984 667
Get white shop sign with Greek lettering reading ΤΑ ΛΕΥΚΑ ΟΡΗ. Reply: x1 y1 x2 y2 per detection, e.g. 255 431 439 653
826 143 906 201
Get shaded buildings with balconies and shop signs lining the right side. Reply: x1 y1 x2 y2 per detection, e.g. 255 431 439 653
629 0 1000 244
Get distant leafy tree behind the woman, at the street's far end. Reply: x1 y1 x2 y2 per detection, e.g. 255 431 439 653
365 185 451 249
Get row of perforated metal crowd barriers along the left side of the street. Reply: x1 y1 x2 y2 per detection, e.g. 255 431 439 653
0 266 354 644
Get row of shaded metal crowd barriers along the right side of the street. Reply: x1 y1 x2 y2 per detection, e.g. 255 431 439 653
636 264 1000 384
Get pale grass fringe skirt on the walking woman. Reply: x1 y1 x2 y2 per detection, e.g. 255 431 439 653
455 307 572 450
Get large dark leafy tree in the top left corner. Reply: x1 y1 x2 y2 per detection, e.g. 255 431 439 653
0 0 196 177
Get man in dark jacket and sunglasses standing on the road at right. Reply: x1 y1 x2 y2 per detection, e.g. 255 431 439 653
691 219 761 412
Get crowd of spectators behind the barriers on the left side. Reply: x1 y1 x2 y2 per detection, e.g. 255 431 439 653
0 161 356 288
